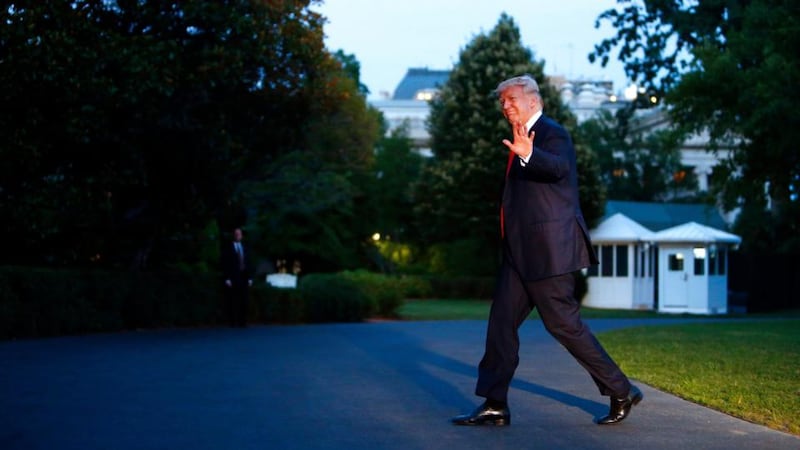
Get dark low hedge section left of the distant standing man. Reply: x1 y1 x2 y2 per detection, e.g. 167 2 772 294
0 267 218 338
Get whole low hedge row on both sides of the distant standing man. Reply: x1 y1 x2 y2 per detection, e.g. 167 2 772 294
0 266 536 339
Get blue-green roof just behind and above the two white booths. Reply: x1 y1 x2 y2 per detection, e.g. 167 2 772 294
605 200 728 231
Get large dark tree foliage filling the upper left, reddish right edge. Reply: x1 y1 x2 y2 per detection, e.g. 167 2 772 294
0 0 377 267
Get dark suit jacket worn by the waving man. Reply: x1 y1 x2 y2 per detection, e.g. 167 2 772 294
502 115 597 281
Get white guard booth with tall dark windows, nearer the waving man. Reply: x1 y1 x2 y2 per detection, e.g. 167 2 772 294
583 213 656 310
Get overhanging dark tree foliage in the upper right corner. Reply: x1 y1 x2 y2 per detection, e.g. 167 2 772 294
590 0 800 252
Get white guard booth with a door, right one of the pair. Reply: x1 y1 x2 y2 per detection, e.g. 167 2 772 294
654 222 742 314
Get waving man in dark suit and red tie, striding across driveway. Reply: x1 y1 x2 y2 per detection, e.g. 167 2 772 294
452 75 642 426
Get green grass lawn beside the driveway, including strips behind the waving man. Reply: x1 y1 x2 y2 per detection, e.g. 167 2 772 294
399 299 800 435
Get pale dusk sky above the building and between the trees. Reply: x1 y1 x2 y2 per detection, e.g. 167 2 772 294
312 0 628 99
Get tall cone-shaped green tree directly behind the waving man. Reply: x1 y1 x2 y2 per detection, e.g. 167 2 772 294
417 13 603 274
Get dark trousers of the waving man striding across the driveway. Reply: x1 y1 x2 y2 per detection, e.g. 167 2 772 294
475 260 631 402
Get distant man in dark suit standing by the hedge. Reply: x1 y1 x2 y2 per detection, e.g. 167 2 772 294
222 228 253 327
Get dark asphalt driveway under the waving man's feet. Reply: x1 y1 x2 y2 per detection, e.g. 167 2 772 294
0 319 800 450
